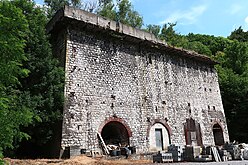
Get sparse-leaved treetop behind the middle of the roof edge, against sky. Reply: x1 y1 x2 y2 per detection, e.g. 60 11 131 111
97 0 143 28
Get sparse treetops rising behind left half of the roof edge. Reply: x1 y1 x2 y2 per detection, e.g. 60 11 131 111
45 0 143 28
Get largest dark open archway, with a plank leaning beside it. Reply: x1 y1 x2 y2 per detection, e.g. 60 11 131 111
101 121 129 146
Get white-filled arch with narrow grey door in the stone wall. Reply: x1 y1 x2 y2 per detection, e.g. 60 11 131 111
149 123 170 151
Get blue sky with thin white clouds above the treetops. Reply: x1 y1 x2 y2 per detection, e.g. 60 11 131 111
36 0 248 37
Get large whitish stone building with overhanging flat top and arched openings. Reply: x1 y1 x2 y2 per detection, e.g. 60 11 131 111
47 6 229 154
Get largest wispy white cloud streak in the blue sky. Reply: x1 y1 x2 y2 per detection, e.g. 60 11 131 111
160 5 207 25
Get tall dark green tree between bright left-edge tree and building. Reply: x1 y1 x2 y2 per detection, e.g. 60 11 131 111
9 0 64 156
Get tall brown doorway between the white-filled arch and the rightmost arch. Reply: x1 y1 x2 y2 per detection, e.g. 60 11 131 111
184 118 202 146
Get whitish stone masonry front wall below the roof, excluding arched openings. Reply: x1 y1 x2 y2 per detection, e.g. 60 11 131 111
62 28 229 153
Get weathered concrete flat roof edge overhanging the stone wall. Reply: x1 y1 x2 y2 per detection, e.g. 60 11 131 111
46 6 218 65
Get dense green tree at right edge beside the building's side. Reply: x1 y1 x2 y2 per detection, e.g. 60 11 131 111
215 40 248 142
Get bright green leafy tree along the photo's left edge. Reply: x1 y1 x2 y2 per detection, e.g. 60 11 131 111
0 1 33 158
